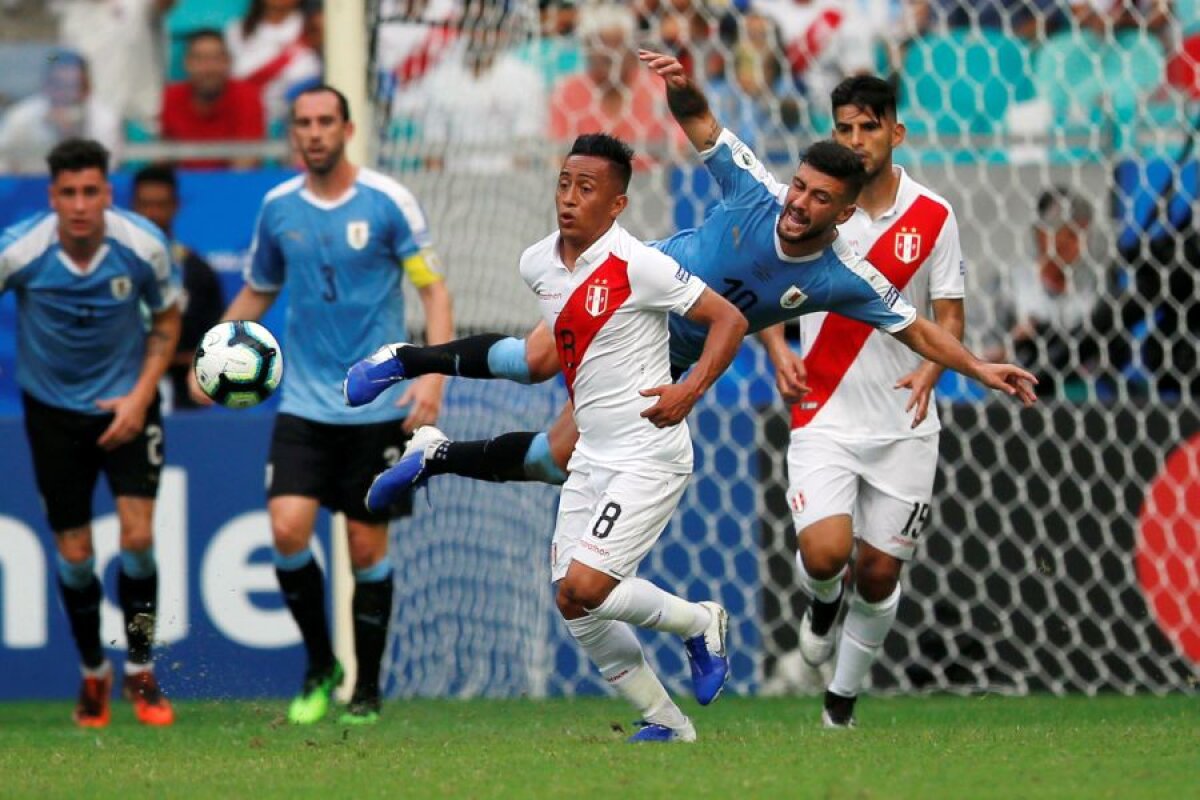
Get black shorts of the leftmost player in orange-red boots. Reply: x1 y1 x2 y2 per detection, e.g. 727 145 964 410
22 392 163 533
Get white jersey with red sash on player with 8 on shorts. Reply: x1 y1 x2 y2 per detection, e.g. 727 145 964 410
521 223 706 474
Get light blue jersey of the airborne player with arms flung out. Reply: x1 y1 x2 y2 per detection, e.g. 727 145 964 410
653 128 917 367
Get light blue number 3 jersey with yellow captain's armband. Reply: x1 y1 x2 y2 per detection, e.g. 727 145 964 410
246 168 440 425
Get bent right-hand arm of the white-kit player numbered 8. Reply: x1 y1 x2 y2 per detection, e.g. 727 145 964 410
641 289 748 428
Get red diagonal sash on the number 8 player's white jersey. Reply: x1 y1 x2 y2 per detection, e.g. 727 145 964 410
554 255 632 401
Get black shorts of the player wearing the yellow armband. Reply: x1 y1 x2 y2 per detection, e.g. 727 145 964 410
266 414 413 522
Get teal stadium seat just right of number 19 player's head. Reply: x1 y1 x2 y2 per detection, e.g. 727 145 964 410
900 29 1033 162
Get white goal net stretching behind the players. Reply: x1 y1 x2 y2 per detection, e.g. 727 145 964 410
367 0 1200 697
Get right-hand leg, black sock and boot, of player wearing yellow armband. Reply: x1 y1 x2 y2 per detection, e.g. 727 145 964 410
338 519 394 724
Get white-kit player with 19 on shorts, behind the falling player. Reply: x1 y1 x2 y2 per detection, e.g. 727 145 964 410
787 76 964 728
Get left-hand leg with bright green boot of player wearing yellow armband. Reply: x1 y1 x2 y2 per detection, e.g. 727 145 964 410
266 494 344 724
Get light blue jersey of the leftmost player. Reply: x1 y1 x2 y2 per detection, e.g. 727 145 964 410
0 209 182 414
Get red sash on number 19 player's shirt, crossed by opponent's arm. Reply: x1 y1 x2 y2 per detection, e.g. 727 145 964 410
792 194 949 428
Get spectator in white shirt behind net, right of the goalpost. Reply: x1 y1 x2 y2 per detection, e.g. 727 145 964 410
398 0 546 173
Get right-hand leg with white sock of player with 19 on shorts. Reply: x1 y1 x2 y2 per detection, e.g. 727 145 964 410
822 540 904 728
